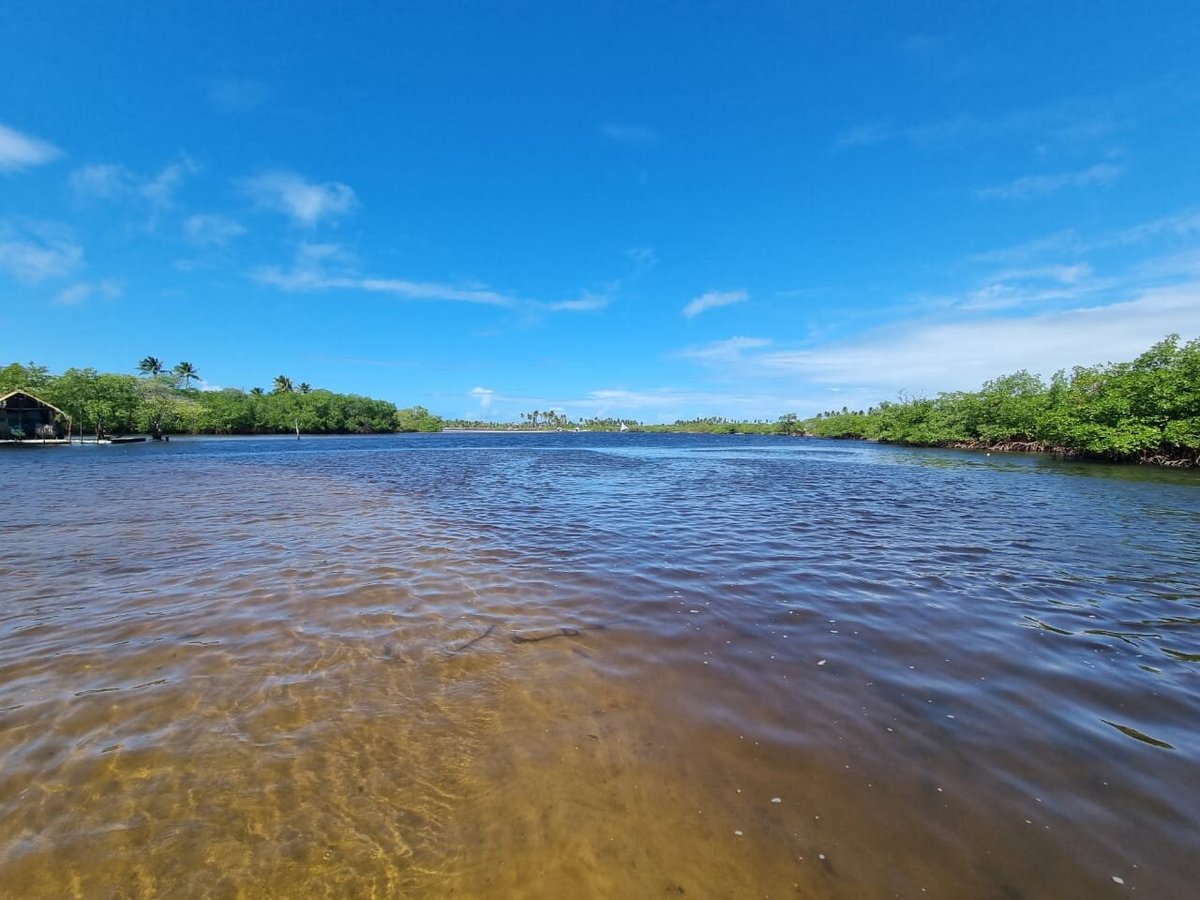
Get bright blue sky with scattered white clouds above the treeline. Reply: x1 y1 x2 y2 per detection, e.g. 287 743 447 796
0 0 1200 421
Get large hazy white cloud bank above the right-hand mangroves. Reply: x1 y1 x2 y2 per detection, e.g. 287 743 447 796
674 202 1200 412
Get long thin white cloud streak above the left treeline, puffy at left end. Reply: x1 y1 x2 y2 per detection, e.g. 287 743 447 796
251 244 518 306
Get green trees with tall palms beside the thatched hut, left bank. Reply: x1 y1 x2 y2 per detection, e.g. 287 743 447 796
0 356 442 434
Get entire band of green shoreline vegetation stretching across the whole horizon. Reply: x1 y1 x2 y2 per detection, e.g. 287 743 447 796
0 335 1200 466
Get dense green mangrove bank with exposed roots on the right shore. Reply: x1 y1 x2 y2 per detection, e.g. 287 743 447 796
803 335 1200 466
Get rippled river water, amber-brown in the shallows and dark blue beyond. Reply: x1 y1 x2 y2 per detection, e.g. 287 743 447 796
0 433 1200 899
